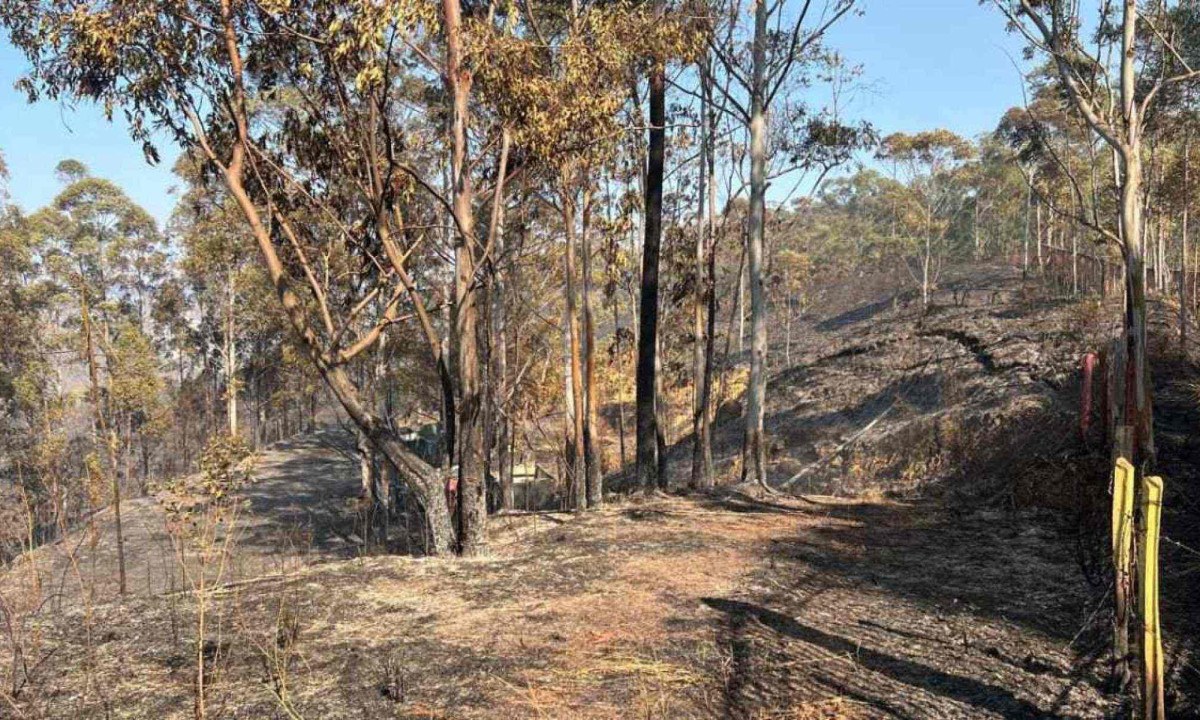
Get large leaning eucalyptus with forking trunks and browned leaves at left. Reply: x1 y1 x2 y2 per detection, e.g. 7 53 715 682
0 0 513 553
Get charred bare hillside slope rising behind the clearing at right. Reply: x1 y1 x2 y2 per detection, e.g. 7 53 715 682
674 266 1116 508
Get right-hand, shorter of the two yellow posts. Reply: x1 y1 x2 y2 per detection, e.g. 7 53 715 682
1138 478 1166 720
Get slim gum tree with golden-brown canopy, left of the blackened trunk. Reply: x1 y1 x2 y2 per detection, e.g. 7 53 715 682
465 5 701 501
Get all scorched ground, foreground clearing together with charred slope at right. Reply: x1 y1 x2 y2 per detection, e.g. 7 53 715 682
0 262 1200 720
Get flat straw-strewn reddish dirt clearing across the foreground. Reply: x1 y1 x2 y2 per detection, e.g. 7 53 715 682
0 444 1106 719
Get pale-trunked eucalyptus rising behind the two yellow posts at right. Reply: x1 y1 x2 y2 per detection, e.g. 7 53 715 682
994 0 1200 464
